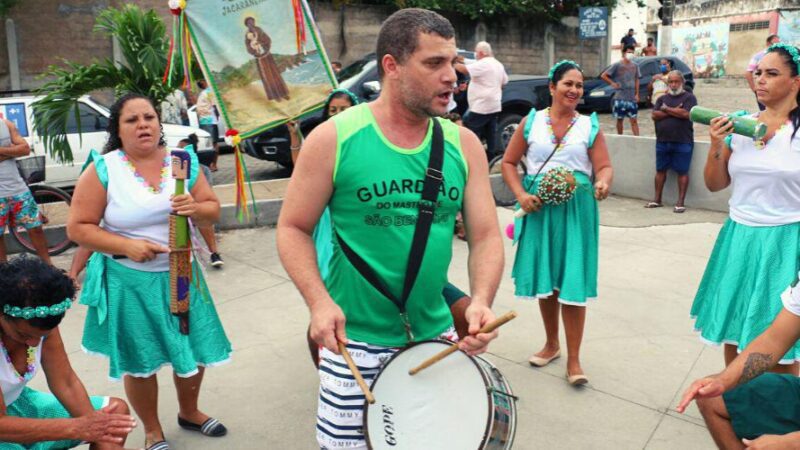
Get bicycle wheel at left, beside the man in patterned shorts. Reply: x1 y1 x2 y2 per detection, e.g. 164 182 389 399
9 184 72 256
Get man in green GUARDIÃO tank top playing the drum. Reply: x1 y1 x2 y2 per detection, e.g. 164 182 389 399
277 9 503 449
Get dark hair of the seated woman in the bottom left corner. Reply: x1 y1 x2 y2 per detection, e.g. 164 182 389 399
0 255 75 330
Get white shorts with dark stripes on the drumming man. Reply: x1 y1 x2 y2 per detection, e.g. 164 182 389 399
317 327 458 450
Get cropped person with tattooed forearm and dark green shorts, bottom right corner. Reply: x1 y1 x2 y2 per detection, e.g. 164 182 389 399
677 272 800 449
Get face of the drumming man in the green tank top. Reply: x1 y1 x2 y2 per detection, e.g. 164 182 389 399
387 33 458 116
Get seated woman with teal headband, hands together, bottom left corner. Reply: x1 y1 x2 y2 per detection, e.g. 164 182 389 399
0 257 136 450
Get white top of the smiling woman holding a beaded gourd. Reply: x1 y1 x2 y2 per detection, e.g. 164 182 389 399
525 111 592 176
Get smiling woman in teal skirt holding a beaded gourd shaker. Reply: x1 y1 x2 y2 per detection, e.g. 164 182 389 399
503 61 613 385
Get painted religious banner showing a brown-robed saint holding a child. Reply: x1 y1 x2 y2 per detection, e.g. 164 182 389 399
184 0 336 138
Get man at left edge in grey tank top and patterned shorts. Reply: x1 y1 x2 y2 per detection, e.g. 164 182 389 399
0 119 50 264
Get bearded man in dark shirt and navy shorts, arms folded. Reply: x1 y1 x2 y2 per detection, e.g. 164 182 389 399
645 70 697 213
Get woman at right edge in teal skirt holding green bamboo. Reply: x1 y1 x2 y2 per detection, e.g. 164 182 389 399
691 44 800 375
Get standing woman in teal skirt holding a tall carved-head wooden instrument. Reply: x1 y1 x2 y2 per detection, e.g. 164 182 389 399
67 94 231 450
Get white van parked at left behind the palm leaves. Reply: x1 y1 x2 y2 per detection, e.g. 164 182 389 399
0 95 213 188
